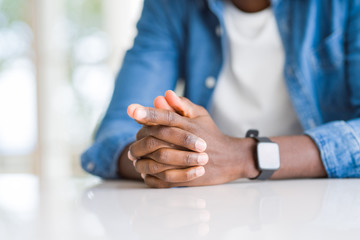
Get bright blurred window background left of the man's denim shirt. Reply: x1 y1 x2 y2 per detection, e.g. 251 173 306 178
0 0 143 177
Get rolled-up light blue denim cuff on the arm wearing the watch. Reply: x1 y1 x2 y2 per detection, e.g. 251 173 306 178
305 119 360 178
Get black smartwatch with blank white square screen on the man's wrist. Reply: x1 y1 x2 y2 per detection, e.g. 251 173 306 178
246 129 280 180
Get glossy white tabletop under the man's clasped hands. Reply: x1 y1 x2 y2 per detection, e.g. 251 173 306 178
0 175 360 240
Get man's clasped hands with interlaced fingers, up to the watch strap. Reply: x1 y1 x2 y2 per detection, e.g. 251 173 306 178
128 91 257 188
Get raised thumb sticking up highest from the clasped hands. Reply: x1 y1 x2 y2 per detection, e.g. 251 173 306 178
165 90 207 118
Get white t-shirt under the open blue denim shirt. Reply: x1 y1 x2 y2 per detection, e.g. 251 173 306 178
210 1 302 137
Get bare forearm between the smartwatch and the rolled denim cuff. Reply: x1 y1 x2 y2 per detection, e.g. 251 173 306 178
246 135 327 179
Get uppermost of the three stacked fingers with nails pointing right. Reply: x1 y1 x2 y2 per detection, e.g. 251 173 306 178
136 126 207 152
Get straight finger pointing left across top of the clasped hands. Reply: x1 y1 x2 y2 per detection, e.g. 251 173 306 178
133 107 190 128
